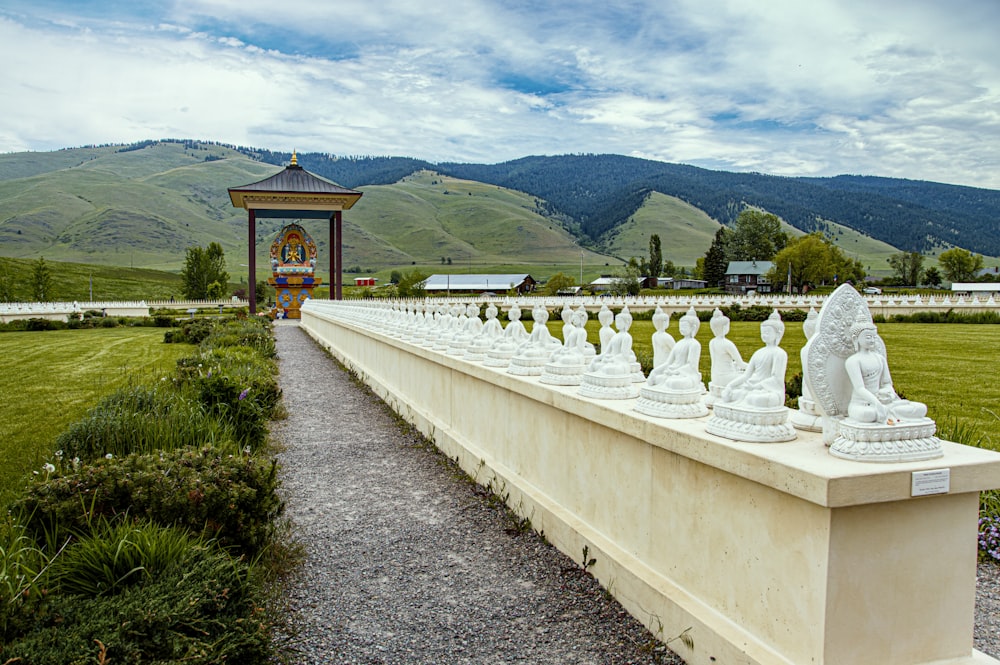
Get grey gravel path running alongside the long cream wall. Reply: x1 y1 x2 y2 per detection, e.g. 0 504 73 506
273 323 1000 665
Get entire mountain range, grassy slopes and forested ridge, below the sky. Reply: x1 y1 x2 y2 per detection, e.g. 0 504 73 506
0 139 1000 271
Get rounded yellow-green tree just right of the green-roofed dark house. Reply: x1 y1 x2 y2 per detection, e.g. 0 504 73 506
768 236 864 289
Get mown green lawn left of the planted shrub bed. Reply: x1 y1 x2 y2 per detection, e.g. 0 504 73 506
0 328 194 506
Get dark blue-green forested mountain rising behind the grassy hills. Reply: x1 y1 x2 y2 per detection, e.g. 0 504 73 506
238 150 1000 256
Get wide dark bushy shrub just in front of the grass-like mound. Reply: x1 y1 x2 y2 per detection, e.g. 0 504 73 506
15 446 284 556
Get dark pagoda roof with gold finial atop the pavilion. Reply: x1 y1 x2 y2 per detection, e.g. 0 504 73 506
229 155 362 219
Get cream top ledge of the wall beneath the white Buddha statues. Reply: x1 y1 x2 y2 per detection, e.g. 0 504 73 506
303 312 1000 508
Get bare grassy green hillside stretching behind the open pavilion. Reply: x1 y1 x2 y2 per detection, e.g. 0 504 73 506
0 141 609 281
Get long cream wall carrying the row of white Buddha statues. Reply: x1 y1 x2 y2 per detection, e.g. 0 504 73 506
301 301 1000 665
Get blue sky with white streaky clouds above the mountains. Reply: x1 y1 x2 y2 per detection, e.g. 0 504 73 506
0 0 1000 189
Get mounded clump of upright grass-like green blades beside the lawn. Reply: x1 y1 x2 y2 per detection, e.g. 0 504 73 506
56 384 240 460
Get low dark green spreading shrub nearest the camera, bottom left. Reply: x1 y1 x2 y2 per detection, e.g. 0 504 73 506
0 527 271 665
